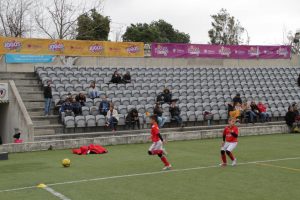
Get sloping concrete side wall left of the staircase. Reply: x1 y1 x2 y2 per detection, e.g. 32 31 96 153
0 81 34 143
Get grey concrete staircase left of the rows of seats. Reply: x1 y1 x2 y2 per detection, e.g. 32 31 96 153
0 72 63 137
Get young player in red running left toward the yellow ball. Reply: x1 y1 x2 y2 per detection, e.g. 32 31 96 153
148 115 172 170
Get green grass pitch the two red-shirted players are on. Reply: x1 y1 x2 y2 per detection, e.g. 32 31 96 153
0 134 300 200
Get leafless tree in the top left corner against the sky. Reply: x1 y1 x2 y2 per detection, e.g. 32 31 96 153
0 0 32 37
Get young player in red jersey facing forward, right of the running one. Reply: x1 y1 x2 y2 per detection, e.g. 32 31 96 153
220 118 239 166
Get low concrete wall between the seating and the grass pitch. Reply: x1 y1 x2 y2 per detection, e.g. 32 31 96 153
0 125 288 152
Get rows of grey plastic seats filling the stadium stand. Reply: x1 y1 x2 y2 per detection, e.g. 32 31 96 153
35 66 299 128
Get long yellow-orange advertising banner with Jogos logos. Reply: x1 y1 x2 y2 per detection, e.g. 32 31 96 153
0 37 144 57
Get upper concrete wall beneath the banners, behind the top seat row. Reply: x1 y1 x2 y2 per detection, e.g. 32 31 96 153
0 55 300 72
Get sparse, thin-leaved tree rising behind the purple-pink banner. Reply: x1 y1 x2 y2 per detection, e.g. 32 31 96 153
208 8 245 45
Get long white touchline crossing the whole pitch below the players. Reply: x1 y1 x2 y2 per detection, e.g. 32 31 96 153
0 157 300 193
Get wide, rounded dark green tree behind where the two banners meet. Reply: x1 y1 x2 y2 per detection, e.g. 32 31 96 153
123 20 190 43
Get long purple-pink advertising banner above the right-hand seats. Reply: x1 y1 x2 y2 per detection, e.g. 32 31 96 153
151 43 291 59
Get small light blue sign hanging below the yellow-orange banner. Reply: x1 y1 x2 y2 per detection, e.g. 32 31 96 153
5 54 55 63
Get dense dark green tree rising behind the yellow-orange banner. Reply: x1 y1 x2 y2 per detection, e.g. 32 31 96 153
76 9 110 41
